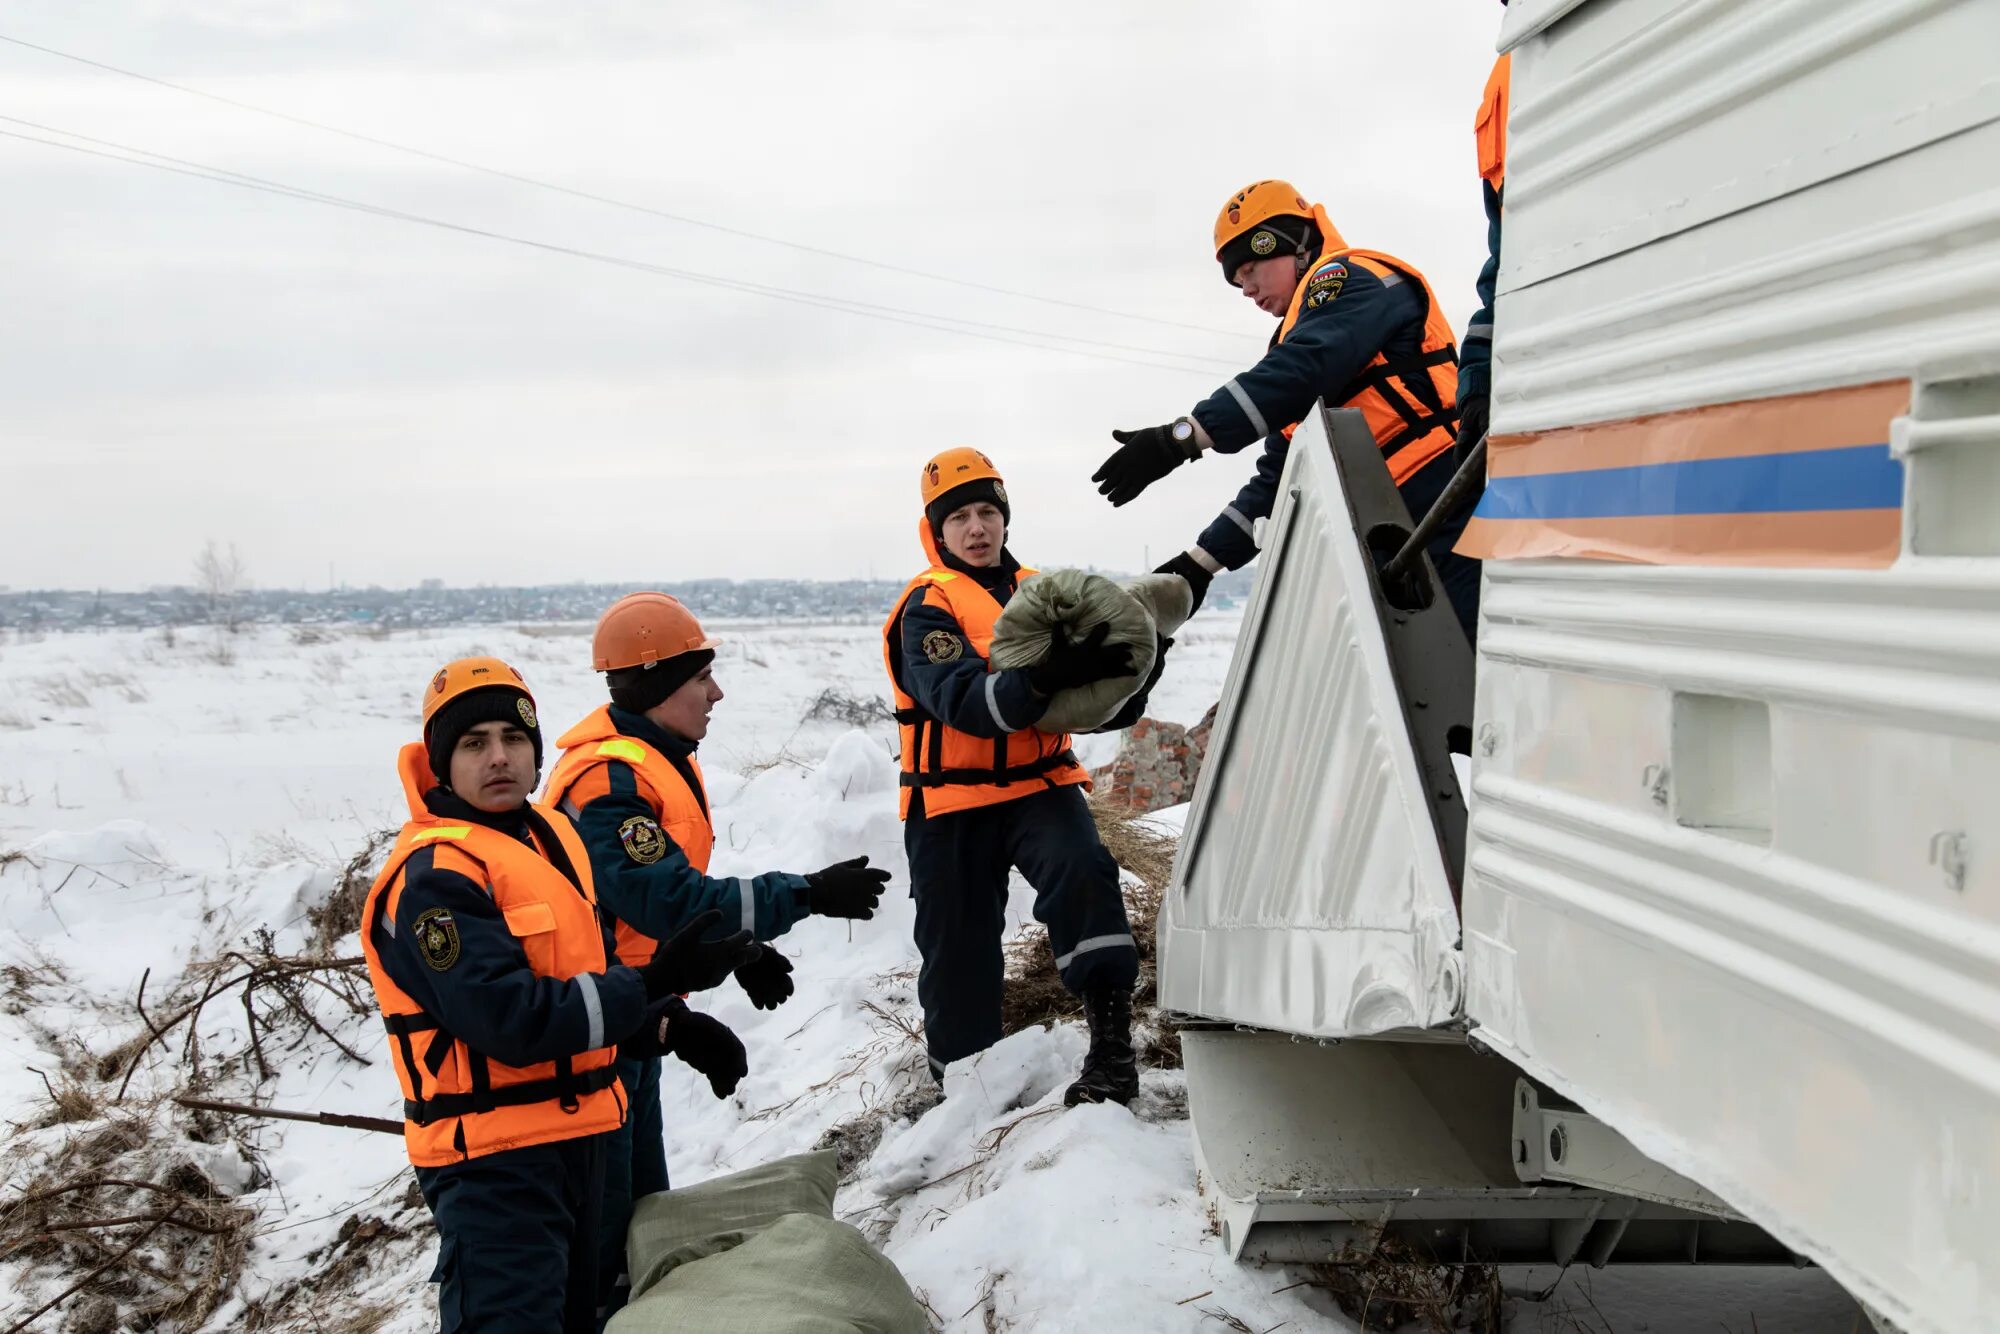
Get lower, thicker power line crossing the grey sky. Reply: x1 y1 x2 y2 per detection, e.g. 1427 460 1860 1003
0 116 1212 376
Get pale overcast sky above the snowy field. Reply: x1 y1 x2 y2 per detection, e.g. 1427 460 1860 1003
0 0 1502 590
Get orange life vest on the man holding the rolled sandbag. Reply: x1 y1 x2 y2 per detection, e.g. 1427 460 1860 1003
882 518 1090 818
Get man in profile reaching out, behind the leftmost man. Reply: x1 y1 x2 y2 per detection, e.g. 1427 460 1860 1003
548 592 888 1310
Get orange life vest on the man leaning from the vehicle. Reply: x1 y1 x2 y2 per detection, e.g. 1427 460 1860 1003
1278 204 1458 486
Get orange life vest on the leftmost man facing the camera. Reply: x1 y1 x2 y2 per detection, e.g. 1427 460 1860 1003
362 742 626 1168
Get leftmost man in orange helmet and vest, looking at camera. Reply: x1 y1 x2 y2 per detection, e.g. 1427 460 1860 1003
362 658 752 1334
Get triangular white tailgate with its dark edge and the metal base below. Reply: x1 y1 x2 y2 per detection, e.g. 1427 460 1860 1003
1158 410 1792 1264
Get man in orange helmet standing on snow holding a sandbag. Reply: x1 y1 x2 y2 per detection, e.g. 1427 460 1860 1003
882 448 1138 1106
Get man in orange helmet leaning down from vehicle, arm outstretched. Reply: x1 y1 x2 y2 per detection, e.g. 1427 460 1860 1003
1090 180 1480 636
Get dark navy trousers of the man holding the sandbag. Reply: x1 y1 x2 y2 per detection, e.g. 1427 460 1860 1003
902 786 1138 1076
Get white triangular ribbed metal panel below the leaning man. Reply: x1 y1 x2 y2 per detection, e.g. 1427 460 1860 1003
1158 412 1460 1038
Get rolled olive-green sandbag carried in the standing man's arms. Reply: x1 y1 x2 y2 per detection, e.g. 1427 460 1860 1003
986 570 1194 732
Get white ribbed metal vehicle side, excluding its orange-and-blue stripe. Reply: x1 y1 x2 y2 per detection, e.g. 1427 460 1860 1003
1464 0 2000 1334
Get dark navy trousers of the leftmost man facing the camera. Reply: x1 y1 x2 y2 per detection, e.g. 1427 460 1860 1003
416 1134 604 1334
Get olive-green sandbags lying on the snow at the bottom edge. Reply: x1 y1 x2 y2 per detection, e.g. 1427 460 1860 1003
608 1150 930 1334
